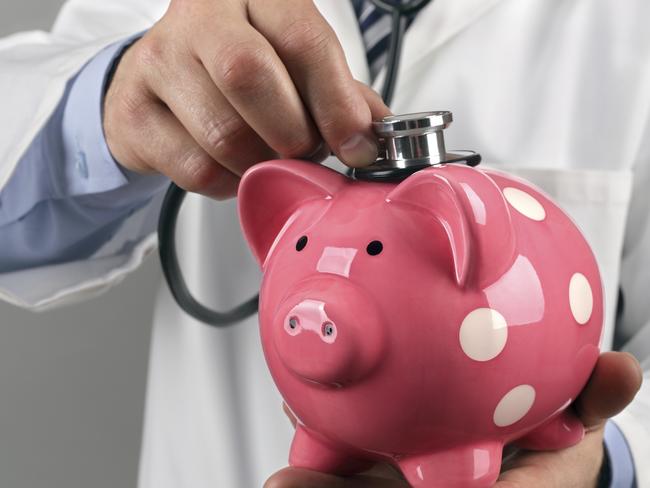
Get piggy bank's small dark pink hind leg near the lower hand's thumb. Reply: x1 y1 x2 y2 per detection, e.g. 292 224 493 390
515 409 585 451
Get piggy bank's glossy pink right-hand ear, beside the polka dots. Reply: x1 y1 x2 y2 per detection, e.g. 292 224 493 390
387 164 516 287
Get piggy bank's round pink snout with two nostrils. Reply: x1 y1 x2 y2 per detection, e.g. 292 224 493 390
274 283 385 386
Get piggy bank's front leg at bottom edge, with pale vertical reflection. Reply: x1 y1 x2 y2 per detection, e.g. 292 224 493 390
398 442 503 488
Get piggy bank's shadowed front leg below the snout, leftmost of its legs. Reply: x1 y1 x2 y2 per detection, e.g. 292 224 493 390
289 424 374 475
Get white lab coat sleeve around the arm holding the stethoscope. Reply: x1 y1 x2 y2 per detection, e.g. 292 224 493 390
0 0 170 309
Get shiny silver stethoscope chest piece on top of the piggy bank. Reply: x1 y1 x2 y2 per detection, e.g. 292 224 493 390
353 111 481 181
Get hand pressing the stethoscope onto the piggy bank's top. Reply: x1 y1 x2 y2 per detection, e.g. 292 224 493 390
104 0 388 198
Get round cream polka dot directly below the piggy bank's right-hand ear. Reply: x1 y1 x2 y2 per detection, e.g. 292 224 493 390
458 308 508 361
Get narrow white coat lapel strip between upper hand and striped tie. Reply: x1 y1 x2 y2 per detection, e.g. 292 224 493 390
315 0 370 83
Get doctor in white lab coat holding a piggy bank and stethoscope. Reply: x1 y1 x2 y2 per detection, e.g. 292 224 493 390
0 0 650 488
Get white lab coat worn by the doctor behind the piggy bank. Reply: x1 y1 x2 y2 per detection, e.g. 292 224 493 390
0 0 650 488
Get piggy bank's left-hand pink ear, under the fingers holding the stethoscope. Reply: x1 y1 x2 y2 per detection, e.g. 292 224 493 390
237 160 346 265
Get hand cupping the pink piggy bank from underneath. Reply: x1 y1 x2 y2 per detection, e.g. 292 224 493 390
264 352 643 488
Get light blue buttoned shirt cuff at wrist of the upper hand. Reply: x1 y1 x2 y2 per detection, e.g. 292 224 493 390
60 33 168 198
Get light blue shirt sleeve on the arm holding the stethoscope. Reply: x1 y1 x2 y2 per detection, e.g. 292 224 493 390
0 35 168 273
